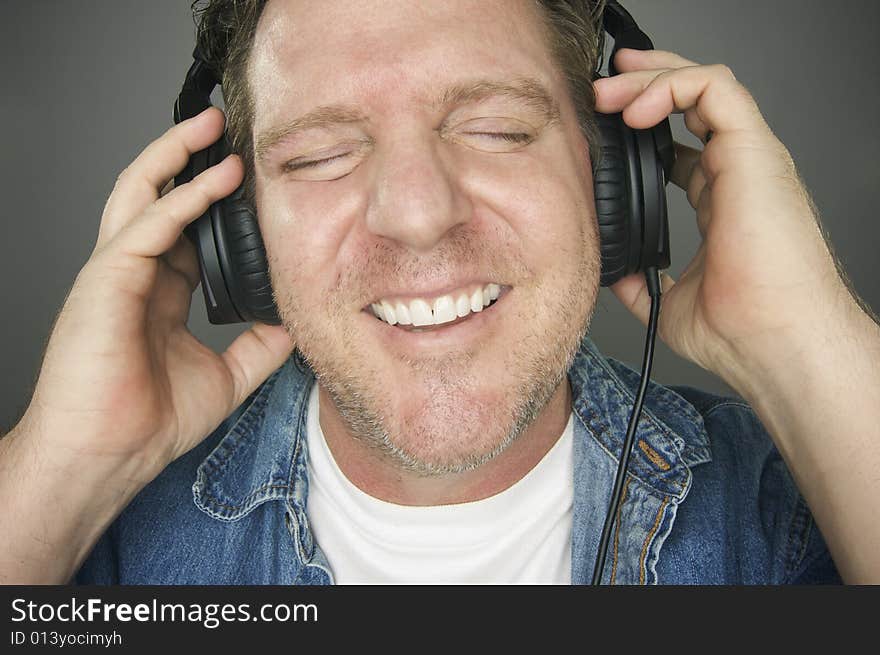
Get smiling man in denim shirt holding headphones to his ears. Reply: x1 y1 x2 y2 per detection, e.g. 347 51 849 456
0 0 880 584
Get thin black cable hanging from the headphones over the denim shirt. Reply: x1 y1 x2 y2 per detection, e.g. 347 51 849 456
593 267 660 585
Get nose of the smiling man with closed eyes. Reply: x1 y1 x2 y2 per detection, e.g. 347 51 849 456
366 132 471 254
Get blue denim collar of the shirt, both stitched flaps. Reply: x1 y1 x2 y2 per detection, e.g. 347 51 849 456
193 337 710 516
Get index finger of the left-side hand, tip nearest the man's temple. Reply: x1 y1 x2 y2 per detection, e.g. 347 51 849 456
108 155 244 257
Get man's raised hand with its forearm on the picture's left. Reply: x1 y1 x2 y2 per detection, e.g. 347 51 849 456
0 108 293 582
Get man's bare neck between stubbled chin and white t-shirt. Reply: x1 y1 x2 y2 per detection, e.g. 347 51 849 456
319 377 571 505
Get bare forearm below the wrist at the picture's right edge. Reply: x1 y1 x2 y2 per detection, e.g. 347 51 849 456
731 303 880 584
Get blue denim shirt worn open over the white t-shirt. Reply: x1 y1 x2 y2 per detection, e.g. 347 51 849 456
76 338 840 585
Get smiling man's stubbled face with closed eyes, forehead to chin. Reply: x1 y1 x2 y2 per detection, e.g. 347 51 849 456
250 0 599 473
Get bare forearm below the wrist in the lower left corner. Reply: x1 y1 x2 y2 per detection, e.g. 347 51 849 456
0 416 153 584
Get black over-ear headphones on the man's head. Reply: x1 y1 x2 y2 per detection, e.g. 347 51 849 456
174 0 675 325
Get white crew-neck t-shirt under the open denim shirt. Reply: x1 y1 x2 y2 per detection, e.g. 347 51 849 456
306 383 574 584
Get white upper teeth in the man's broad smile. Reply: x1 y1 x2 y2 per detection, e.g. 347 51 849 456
370 283 501 327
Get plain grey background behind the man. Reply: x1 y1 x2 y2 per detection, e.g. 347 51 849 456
0 0 880 430
